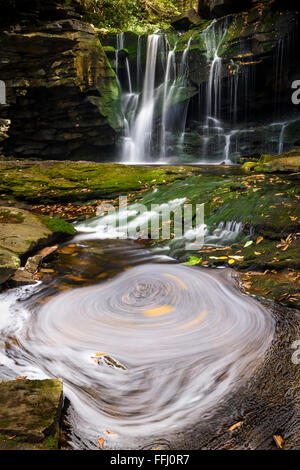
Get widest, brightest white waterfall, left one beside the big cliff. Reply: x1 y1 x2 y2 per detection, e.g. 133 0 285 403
118 34 192 163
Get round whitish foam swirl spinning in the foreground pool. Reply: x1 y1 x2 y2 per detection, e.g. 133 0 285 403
19 264 274 436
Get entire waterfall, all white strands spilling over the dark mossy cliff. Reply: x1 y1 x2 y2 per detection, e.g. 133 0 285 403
116 13 298 164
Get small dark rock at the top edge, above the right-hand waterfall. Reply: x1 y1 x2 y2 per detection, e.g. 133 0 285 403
198 0 252 18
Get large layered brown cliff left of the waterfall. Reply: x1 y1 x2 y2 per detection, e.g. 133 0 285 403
0 2 122 160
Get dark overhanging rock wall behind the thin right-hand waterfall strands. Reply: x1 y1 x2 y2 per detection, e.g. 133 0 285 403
177 2 300 125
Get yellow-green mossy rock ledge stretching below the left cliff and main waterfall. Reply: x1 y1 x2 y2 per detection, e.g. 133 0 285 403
0 162 197 203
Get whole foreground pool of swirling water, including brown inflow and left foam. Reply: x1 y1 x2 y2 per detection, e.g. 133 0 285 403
0 241 274 448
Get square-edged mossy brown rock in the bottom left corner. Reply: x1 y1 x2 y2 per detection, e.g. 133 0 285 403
0 379 63 450
